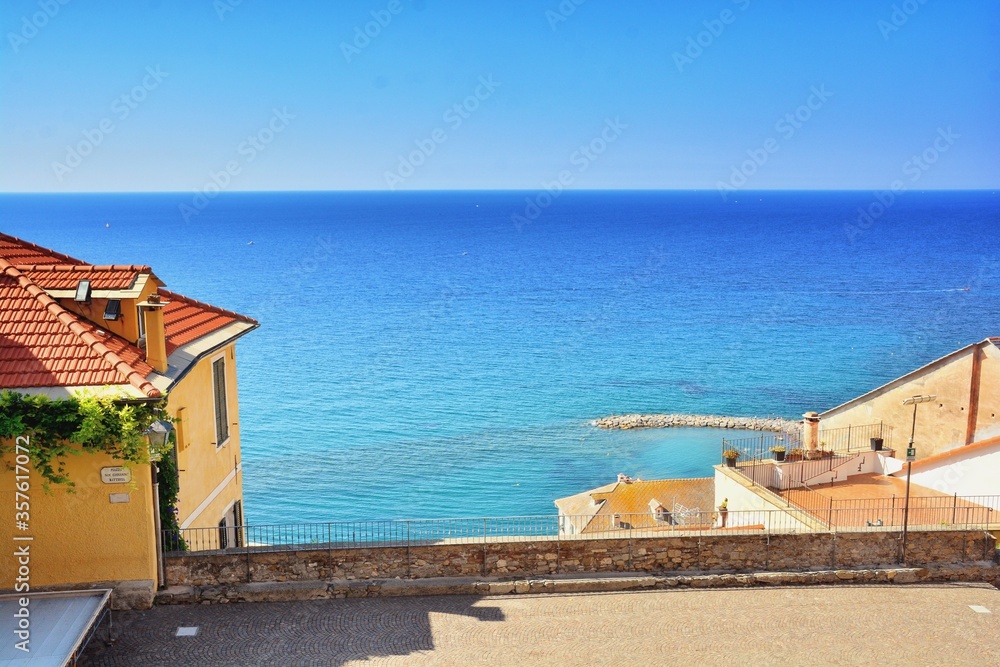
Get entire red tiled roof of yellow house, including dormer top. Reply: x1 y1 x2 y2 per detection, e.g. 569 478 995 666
0 233 257 397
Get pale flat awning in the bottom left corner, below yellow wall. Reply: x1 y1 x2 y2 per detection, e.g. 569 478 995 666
0 589 111 667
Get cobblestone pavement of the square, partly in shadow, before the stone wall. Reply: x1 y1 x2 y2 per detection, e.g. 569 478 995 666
81 584 1000 667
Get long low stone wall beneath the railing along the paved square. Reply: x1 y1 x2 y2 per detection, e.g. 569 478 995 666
166 531 996 586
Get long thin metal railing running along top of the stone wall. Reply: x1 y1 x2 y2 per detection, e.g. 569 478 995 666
163 496 1000 555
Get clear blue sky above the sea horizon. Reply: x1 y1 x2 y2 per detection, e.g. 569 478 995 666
0 0 1000 192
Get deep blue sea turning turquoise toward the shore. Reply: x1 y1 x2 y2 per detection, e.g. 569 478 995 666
0 191 1000 524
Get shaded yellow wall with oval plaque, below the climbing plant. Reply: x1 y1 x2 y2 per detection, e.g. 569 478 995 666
0 443 156 589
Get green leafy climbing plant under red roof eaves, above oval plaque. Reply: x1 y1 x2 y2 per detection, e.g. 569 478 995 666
0 390 168 491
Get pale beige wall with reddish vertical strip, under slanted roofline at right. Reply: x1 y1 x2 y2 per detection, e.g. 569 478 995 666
820 345 1000 459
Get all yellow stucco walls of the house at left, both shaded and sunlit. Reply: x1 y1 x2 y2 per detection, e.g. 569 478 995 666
0 345 243 589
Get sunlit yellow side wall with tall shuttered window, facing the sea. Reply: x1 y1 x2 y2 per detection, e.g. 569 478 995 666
167 344 243 528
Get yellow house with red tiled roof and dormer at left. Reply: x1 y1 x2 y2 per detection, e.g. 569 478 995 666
0 234 259 607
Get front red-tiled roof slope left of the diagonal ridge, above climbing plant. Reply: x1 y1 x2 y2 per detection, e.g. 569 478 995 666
0 259 161 398
